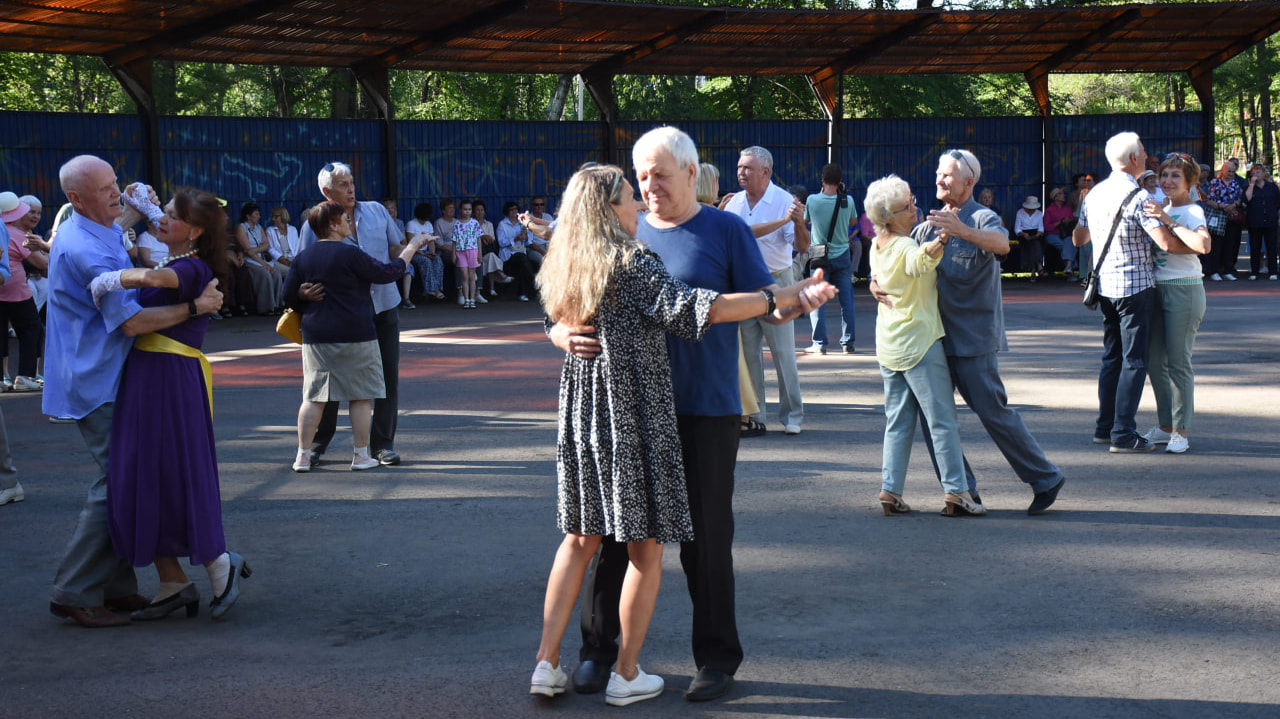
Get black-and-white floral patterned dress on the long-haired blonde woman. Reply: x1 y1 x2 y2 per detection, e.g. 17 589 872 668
557 252 718 542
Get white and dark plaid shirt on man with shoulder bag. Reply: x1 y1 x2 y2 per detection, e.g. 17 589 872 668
1080 170 1160 299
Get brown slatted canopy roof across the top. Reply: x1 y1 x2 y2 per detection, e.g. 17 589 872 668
0 0 1280 77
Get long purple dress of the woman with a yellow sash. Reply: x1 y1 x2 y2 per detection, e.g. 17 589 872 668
106 257 227 567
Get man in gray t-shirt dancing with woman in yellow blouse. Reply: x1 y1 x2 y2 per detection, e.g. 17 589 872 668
873 150 1064 514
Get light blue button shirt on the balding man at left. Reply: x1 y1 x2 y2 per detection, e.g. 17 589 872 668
44 212 142 420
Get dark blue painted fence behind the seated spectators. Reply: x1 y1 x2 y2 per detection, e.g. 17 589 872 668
0 113 1201 230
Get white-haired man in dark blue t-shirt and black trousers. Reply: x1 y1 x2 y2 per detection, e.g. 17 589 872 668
550 127 814 701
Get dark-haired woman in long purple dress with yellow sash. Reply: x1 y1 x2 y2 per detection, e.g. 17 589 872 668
91 188 250 619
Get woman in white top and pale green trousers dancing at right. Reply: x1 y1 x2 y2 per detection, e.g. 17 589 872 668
1143 152 1211 454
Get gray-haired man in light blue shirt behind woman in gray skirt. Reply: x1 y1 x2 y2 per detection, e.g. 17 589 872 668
298 162 404 466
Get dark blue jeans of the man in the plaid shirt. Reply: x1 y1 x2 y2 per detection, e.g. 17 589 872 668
1093 287 1156 444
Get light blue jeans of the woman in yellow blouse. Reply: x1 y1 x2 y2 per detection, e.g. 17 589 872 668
881 339 969 495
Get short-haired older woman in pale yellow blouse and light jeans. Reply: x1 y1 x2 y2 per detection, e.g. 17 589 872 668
865 175 987 516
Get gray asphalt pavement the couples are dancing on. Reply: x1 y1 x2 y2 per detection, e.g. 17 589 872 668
0 280 1280 719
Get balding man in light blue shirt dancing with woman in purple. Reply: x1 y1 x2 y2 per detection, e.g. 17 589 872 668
44 155 223 627
